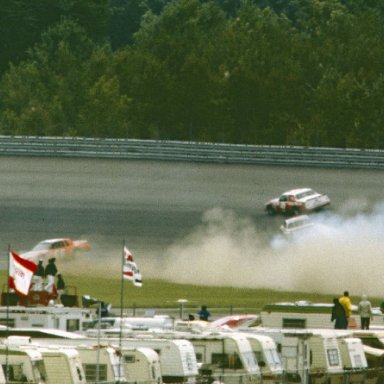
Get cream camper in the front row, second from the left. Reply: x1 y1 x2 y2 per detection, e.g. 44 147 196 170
38 347 86 384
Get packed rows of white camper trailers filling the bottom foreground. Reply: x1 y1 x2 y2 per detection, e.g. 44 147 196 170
0 306 384 384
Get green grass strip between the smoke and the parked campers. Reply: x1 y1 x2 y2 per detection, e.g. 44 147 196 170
0 271 381 313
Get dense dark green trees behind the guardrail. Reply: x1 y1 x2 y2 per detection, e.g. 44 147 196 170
0 0 384 148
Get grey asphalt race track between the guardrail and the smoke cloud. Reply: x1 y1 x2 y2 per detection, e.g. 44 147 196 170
0 157 384 280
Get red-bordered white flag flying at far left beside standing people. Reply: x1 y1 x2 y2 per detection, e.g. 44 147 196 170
9 251 37 296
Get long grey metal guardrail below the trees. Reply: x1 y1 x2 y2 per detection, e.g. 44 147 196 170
0 136 384 169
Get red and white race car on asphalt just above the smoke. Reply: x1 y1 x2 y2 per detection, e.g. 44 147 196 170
265 188 331 215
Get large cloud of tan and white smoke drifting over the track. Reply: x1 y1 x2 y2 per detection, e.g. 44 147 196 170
149 205 384 295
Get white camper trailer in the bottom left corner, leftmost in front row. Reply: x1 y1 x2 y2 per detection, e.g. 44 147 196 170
0 340 46 384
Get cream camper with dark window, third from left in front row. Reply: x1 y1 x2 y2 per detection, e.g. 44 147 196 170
76 345 127 383
